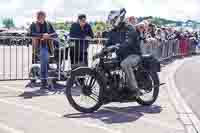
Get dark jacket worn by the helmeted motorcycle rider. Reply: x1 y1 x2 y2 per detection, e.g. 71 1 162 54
107 23 141 60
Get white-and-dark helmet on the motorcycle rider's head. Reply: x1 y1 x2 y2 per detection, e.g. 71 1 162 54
107 8 126 28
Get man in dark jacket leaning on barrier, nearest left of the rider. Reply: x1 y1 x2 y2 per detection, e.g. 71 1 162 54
69 14 94 67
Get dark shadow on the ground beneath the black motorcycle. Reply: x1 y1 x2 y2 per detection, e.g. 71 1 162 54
64 105 162 124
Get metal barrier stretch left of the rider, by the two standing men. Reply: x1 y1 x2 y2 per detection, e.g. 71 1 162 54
0 36 106 81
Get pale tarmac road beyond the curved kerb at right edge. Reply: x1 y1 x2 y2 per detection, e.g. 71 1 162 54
175 56 200 121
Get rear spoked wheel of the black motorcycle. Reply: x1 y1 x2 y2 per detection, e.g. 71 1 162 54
136 72 160 106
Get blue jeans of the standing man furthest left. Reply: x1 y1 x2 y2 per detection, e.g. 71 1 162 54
40 47 49 80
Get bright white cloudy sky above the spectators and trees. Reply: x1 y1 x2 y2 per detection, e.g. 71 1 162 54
0 0 200 25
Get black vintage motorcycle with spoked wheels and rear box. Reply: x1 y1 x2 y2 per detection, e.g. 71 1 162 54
65 46 160 113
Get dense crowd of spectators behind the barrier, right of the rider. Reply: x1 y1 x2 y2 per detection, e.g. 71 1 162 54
97 17 200 56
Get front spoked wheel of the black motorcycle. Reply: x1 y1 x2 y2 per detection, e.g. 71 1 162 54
66 69 103 113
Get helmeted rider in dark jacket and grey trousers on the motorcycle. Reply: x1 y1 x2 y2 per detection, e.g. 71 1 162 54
107 8 145 97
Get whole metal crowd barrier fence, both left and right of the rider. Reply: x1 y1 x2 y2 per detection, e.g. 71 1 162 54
0 36 196 81
